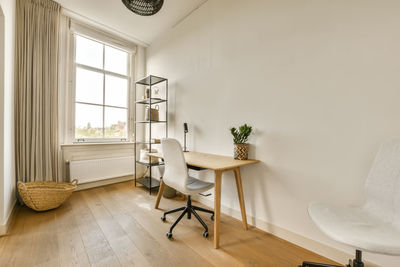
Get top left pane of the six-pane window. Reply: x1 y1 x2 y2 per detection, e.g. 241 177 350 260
75 35 103 69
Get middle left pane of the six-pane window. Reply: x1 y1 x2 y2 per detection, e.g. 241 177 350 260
75 68 104 104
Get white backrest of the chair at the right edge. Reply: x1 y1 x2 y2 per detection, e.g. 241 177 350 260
364 140 400 229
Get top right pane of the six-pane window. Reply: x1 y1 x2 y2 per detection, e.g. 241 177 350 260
104 46 128 75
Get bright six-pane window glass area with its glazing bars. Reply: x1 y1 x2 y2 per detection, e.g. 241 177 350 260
73 34 131 142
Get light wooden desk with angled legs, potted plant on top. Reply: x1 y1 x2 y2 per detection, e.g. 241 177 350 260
149 152 259 248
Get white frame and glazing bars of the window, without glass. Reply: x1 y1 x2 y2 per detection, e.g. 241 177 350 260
68 24 136 143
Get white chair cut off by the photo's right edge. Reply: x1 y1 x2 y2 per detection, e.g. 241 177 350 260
302 141 400 267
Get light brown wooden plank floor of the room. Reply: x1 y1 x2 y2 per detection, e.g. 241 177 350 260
0 182 334 267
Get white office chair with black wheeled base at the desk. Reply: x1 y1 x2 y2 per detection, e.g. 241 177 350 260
161 138 214 238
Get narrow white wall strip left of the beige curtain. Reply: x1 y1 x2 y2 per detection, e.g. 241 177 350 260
0 0 15 231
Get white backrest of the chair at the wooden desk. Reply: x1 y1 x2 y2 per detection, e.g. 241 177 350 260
161 138 189 194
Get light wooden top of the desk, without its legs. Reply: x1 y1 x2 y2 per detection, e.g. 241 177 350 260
148 152 260 171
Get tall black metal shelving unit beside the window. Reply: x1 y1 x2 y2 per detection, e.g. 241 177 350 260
134 75 168 194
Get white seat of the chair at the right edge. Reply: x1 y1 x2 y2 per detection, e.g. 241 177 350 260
308 203 400 255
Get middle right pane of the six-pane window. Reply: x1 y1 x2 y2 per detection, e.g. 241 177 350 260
106 75 128 107
